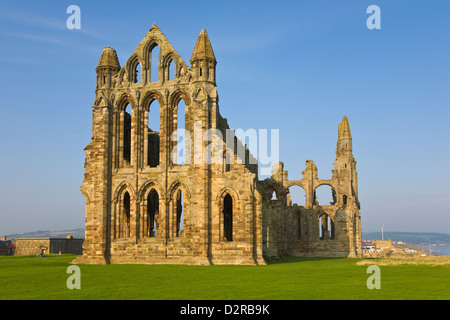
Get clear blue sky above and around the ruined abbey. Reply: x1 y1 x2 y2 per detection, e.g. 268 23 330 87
0 0 450 234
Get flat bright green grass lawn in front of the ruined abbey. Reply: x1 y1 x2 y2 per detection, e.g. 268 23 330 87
0 255 450 300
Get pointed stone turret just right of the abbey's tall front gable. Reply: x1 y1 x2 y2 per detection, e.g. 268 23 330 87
191 29 217 84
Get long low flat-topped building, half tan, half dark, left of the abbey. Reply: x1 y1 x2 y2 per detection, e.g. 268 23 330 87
14 236 84 256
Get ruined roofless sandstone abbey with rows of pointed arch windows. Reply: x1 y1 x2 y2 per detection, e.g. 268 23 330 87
73 25 361 265
